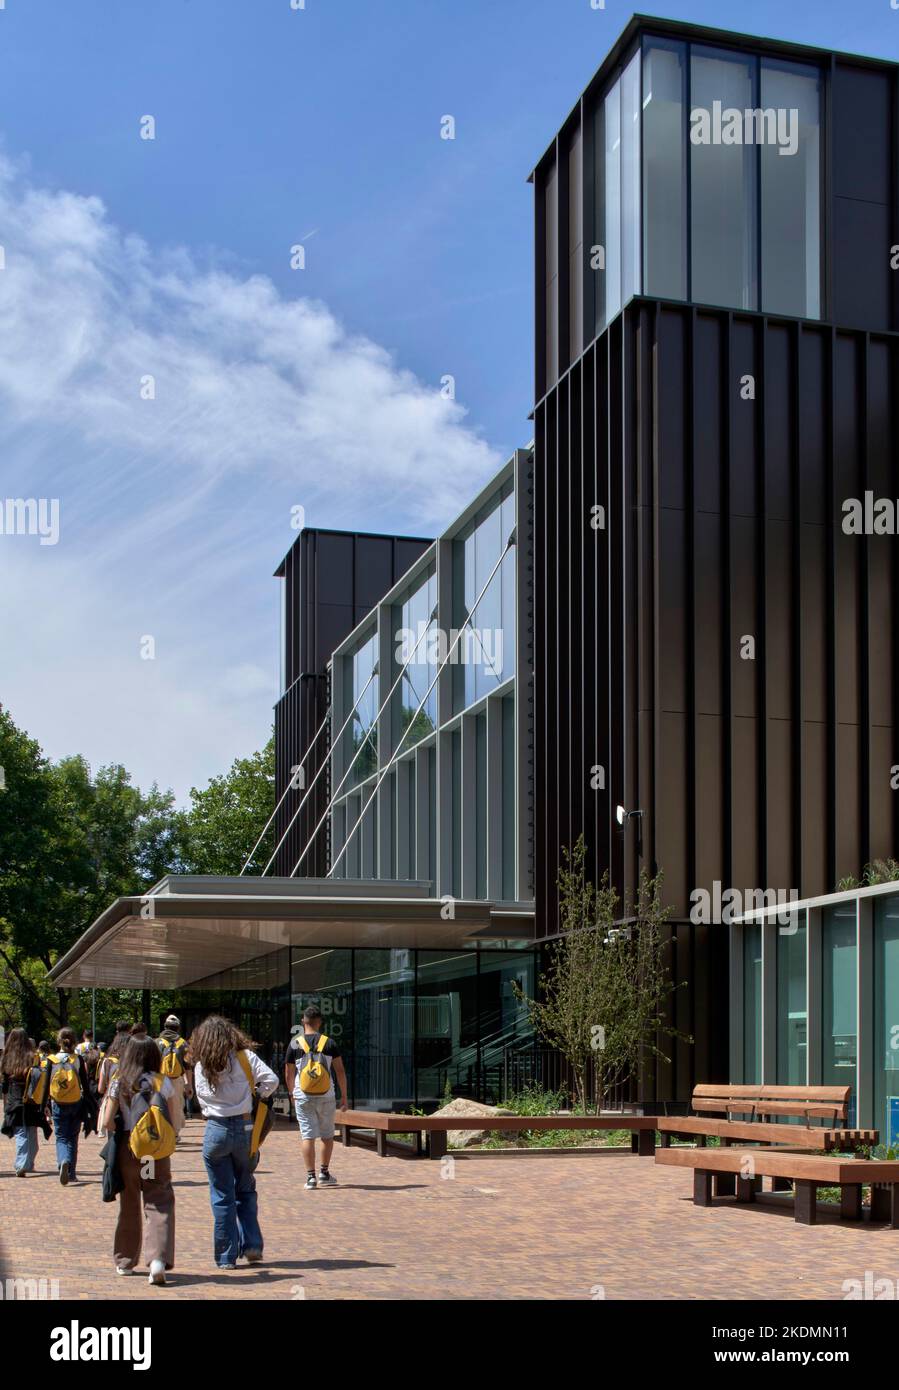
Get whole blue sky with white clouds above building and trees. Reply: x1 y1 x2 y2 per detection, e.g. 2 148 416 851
0 0 899 798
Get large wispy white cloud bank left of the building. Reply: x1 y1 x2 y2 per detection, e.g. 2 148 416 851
0 149 502 796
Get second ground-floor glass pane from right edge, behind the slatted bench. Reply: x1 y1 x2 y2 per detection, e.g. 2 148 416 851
821 902 859 1105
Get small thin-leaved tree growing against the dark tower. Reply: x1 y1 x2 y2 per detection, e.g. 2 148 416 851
527 837 692 1112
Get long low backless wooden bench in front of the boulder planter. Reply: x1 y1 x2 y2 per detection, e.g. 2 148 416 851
335 1111 659 1159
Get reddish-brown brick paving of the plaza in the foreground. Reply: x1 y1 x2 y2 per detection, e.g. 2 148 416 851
0 1120 899 1300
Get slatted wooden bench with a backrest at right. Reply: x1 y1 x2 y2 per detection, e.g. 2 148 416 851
657 1086 880 1151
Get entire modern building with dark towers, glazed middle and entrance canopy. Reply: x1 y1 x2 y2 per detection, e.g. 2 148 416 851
53 17 899 1123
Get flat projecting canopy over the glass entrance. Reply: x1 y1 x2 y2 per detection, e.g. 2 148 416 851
50 874 535 990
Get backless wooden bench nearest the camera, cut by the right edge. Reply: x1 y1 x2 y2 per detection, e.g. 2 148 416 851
656 1148 899 1230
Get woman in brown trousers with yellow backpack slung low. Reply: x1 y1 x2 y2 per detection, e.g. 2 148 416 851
100 1038 175 1284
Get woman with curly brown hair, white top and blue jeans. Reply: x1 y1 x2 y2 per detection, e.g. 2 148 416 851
188 1015 278 1269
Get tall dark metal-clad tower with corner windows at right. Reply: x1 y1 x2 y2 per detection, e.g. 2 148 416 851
532 8 899 1099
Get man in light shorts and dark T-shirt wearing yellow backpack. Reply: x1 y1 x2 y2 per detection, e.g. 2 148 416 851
285 1005 349 1190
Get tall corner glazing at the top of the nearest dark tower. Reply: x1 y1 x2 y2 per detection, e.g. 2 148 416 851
636 36 823 322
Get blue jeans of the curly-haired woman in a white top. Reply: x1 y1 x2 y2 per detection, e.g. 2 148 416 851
203 1115 263 1265
